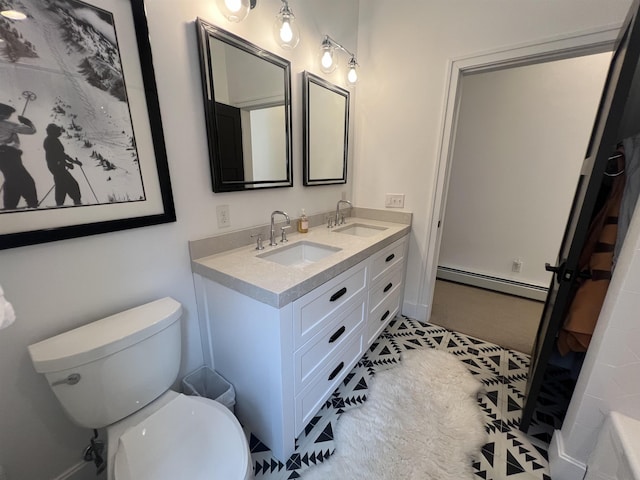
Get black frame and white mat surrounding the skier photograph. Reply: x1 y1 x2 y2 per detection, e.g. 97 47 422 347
0 0 176 250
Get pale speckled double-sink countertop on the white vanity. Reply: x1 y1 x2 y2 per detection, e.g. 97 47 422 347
191 217 411 308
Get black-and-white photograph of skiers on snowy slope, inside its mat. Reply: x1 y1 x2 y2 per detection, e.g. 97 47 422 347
0 0 146 213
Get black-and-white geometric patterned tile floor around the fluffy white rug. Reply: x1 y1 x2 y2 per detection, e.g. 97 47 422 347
246 316 572 480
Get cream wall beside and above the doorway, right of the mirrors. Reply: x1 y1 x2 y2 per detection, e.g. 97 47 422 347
354 0 630 314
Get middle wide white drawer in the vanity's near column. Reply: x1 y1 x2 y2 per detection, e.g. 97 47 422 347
294 295 367 392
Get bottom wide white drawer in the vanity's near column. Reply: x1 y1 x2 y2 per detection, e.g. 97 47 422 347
294 335 364 436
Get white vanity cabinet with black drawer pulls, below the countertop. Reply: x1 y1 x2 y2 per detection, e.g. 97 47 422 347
194 232 408 462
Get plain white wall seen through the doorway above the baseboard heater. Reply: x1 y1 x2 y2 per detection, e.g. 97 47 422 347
438 56 611 288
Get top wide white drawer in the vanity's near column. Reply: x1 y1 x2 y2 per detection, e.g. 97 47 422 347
293 262 367 348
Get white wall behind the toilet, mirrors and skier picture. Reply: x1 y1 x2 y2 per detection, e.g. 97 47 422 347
0 0 358 480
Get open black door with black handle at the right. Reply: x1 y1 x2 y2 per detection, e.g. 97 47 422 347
520 0 640 432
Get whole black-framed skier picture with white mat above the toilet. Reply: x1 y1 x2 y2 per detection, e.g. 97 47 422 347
0 0 176 249
